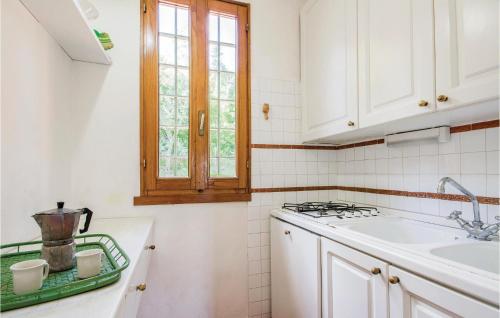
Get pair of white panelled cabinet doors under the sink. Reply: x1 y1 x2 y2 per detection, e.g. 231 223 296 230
321 238 499 318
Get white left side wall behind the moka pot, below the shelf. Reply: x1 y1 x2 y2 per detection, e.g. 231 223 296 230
1 0 71 243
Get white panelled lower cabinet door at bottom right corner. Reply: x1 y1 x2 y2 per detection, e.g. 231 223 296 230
389 266 500 318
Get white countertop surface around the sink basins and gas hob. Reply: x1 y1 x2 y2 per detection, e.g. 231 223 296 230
271 209 500 306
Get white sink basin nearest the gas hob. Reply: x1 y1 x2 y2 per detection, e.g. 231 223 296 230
342 218 457 244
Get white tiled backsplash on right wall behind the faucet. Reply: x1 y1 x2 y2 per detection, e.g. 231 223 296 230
336 128 499 222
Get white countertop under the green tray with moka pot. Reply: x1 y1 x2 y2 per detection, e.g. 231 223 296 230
1 217 153 318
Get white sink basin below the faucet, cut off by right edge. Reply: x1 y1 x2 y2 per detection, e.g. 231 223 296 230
431 242 500 275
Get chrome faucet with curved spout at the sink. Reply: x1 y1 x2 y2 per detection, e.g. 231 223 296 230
437 177 500 241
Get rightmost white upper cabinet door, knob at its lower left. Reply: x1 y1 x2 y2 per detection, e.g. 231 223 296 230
434 0 500 109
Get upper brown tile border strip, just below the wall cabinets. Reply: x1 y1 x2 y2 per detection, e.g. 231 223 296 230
251 119 500 150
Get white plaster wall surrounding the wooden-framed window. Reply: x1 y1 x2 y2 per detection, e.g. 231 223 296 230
66 0 299 318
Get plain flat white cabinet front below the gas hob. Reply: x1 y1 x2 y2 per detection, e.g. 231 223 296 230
271 218 321 318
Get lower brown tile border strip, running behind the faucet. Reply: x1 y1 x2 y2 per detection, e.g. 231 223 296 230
252 186 500 205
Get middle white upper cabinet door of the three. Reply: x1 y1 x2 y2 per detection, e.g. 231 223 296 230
358 0 436 127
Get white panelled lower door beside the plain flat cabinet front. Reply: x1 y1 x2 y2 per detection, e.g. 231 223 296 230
321 238 392 318
